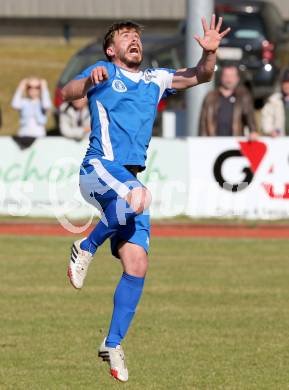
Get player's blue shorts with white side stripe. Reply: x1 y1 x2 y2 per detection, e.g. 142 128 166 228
79 158 150 258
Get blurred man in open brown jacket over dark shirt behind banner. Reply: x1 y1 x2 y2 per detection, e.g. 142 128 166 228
199 65 257 138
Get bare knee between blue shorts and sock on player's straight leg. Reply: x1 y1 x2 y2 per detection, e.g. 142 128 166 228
118 241 148 278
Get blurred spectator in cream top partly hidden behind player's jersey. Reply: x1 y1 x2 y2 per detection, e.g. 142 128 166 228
59 97 90 141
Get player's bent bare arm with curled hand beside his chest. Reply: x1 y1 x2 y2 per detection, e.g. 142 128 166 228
61 66 108 101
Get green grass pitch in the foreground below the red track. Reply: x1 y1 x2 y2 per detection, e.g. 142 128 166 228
0 236 289 390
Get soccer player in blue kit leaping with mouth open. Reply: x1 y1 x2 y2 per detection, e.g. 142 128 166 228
62 15 230 382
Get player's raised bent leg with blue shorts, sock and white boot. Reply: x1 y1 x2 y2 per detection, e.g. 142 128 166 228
67 160 151 288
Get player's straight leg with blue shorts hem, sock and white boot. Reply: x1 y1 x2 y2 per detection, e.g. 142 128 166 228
99 214 150 381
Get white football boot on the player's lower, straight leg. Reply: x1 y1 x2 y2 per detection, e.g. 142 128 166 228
98 338 128 382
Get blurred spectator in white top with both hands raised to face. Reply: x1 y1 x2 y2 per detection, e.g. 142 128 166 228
12 77 51 138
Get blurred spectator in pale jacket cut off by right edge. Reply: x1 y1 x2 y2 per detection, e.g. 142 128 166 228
261 69 289 137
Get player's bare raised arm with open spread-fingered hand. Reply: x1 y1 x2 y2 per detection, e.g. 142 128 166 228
172 15 230 89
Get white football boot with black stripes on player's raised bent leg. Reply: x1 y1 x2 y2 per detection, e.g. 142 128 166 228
67 238 93 289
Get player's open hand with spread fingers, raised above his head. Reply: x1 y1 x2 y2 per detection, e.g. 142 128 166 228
194 14 231 52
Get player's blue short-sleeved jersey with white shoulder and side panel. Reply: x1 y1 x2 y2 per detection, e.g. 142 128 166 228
76 61 175 167
